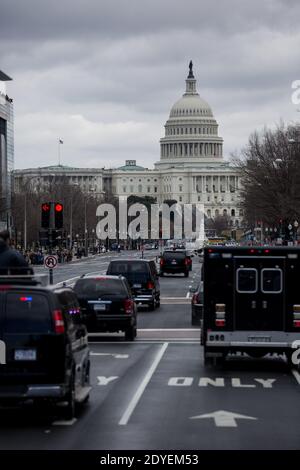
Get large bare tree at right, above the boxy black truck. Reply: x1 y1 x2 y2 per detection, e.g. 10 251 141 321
234 124 300 230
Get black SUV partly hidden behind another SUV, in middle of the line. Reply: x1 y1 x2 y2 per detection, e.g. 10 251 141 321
107 259 160 310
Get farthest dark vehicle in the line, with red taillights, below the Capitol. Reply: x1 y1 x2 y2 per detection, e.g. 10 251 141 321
160 249 192 277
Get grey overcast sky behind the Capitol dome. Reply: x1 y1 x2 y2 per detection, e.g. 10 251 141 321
0 0 300 168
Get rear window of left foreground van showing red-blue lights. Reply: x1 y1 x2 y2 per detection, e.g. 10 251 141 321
4 292 52 333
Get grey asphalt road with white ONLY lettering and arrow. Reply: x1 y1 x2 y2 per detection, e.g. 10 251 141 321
0 252 300 450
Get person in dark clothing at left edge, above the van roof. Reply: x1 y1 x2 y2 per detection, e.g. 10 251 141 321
0 230 33 276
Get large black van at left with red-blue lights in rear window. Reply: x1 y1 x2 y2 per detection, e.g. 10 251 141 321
0 277 90 419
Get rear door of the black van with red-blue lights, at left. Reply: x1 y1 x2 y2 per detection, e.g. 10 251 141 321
0 290 65 384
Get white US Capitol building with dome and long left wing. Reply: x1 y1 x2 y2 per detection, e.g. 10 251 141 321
14 62 242 227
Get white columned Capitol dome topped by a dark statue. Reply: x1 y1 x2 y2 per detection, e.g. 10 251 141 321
158 61 223 168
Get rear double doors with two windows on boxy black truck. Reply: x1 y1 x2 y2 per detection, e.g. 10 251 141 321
234 256 285 331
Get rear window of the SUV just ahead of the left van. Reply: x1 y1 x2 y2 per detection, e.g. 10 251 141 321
74 278 126 296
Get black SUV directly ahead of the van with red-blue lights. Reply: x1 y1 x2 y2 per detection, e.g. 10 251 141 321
74 273 137 341
